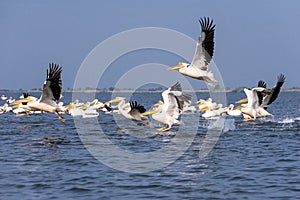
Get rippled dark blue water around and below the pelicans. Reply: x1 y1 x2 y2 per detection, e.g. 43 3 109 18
0 93 300 199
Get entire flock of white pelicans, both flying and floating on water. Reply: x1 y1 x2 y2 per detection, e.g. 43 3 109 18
0 17 286 132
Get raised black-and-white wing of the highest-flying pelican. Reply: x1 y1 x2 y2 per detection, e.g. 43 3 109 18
191 17 215 70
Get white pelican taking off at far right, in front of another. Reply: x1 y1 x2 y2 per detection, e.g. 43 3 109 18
241 87 272 121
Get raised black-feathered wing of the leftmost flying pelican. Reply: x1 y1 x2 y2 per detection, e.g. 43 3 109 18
41 63 62 103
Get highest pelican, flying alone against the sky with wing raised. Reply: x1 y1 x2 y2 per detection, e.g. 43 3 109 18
168 17 218 87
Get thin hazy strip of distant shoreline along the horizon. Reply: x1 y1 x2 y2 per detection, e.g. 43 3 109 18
0 88 300 93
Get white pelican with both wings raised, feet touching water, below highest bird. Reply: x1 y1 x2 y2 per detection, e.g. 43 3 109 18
144 82 191 132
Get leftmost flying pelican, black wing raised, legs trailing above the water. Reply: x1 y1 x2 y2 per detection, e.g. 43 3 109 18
13 63 65 122
